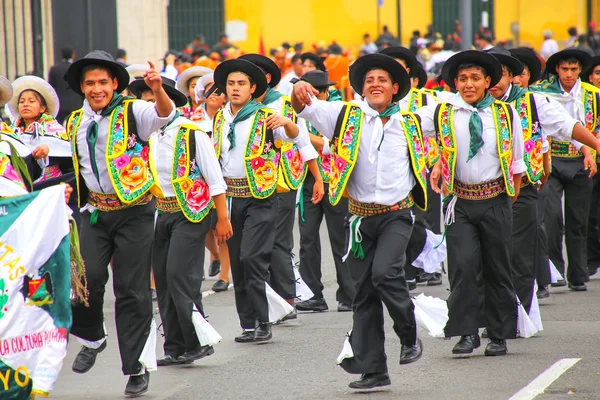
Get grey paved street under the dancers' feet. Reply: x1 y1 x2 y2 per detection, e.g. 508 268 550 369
51 225 600 400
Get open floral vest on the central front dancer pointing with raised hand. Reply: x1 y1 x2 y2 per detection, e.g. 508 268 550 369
329 103 427 210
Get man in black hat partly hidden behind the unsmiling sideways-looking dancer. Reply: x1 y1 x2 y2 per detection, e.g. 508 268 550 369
240 54 324 319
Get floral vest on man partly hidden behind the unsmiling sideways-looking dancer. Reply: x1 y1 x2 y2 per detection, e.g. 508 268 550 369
275 96 308 191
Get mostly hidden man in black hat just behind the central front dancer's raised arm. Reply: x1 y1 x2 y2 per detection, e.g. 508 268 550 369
296 70 355 311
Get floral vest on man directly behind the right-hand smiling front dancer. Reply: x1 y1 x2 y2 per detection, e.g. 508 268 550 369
513 92 544 183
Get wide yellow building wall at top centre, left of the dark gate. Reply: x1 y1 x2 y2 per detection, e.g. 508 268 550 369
225 0 432 54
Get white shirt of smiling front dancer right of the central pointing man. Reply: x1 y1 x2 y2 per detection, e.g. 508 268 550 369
417 93 526 185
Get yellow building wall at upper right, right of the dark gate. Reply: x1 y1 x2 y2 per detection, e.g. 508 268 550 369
494 0 587 51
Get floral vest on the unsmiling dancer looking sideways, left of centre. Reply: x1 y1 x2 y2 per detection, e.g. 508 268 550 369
213 108 281 199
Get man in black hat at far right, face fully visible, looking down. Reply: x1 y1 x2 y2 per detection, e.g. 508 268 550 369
531 49 600 291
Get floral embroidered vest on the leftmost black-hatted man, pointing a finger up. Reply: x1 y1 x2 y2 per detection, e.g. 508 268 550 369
67 100 154 205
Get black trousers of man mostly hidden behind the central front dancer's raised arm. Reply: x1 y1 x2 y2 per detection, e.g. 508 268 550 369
298 174 355 304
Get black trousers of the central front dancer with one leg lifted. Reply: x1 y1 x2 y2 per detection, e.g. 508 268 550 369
341 209 417 374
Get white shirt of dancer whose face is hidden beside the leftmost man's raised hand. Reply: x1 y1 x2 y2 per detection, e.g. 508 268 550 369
151 117 227 197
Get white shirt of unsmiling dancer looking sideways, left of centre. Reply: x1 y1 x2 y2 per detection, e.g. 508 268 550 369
221 102 300 179
